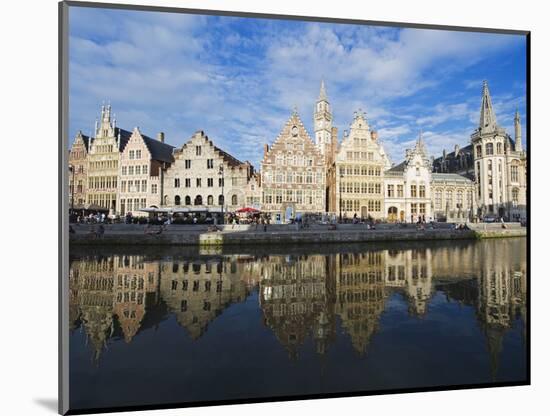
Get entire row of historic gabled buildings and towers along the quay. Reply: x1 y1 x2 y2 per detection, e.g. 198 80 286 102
69 82 527 222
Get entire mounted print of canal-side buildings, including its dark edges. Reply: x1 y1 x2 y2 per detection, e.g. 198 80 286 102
59 2 530 414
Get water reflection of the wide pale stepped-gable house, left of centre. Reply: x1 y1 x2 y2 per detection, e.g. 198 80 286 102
160 259 248 339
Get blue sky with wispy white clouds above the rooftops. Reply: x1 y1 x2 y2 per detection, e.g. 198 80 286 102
69 6 526 168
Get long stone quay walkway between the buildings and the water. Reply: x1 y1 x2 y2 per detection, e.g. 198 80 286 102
70 223 527 245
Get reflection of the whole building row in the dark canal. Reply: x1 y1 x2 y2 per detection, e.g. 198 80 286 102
70 240 526 359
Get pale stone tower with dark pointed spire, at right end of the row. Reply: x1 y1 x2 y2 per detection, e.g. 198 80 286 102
471 81 513 217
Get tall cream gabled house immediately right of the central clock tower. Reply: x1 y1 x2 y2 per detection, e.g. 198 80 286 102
328 111 391 218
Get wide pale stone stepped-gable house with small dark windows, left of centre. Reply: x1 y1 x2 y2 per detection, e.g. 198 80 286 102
163 131 253 216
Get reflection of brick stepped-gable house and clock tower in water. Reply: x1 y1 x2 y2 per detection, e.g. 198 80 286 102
260 255 334 358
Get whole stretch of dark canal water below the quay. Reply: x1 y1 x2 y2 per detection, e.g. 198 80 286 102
69 238 527 409
